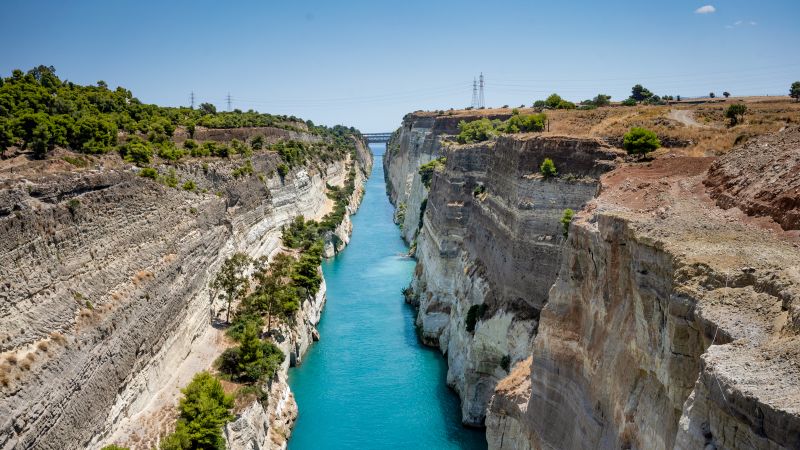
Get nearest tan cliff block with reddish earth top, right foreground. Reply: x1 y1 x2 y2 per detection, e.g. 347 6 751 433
487 153 800 449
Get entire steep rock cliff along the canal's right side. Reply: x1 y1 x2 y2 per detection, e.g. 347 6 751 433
385 110 800 449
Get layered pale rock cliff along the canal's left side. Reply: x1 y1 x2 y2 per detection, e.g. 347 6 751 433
0 134 371 449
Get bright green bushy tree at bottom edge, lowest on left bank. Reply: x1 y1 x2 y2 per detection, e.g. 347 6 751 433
176 372 234 450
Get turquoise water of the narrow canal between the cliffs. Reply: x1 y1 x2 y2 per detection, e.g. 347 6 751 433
289 145 486 450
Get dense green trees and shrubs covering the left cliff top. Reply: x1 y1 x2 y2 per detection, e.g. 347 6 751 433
0 66 360 162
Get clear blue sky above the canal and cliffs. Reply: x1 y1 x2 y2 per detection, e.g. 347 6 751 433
0 0 800 132
